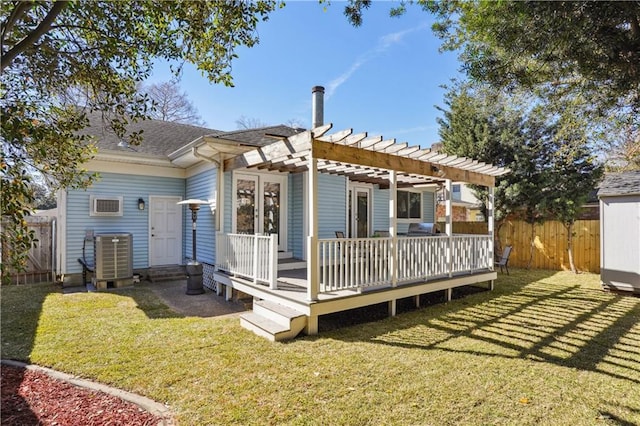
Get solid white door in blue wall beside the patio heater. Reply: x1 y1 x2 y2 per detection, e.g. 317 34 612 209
149 196 182 266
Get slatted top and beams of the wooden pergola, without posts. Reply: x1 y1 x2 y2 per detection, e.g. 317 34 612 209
224 124 508 188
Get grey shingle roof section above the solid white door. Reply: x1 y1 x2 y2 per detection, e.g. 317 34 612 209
82 113 222 156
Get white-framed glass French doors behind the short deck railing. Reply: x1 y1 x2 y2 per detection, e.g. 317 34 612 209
232 173 287 251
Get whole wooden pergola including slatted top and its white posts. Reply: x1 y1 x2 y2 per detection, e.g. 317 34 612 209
223 124 509 301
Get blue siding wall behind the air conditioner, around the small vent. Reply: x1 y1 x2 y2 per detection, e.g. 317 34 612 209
65 173 185 274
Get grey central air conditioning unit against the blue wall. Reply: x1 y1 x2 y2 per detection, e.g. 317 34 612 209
93 234 133 281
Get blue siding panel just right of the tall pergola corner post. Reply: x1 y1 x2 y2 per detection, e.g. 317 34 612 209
318 173 347 238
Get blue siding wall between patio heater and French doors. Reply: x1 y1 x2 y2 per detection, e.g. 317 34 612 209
182 168 217 264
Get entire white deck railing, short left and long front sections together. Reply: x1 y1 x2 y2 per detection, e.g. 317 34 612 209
216 234 493 293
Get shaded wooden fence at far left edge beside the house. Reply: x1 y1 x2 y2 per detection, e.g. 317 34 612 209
2 216 55 284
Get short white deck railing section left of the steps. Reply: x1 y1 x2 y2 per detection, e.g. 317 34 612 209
216 233 278 289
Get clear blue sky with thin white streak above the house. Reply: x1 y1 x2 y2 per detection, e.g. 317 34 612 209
148 1 460 148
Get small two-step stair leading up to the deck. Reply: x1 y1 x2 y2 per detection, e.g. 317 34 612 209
240 299 307 342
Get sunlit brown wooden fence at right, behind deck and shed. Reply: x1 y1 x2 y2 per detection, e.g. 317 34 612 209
453 220 600 273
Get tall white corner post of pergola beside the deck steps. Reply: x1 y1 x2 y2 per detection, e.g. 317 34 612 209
307 155 320 302
